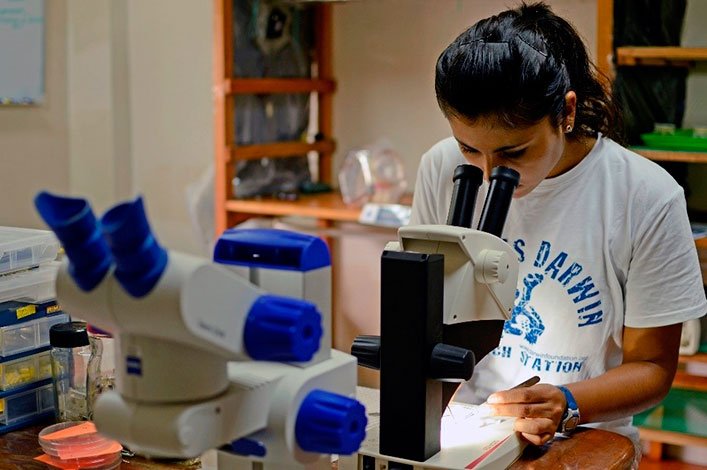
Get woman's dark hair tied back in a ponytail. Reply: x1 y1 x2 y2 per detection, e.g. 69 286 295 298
435 3 619 139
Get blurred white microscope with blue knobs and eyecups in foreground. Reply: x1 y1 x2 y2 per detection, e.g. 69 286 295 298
35 193 366 470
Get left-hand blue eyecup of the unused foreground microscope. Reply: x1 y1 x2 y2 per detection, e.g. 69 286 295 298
34 191 113 292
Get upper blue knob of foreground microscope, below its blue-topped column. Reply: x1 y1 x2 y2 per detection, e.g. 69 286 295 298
243 295 322 362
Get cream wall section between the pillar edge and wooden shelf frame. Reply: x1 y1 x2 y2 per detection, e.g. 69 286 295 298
127 0 213 253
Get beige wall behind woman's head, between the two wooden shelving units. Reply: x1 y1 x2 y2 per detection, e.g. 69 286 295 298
334 0 596 184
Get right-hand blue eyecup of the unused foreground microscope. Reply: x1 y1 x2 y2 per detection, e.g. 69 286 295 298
101 197 167 297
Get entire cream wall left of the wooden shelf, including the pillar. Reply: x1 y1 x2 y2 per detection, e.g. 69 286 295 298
0 0 213 253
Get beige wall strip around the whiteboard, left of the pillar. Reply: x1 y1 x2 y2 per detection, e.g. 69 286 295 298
0 0 69 228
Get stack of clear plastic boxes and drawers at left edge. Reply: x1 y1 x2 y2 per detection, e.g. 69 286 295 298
0 227 69 434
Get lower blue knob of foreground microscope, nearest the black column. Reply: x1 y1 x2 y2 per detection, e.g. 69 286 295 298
295 390 368 454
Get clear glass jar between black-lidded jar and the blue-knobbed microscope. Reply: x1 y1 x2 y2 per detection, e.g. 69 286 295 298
86 325 115 418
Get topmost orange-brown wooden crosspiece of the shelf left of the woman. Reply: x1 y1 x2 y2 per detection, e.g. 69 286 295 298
224 78 336 95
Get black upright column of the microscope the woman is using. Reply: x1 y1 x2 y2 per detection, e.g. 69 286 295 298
380 251 444 462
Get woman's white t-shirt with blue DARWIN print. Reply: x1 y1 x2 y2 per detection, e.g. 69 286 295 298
410 136 707 441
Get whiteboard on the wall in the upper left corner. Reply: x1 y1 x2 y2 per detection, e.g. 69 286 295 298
0 0 44 105
